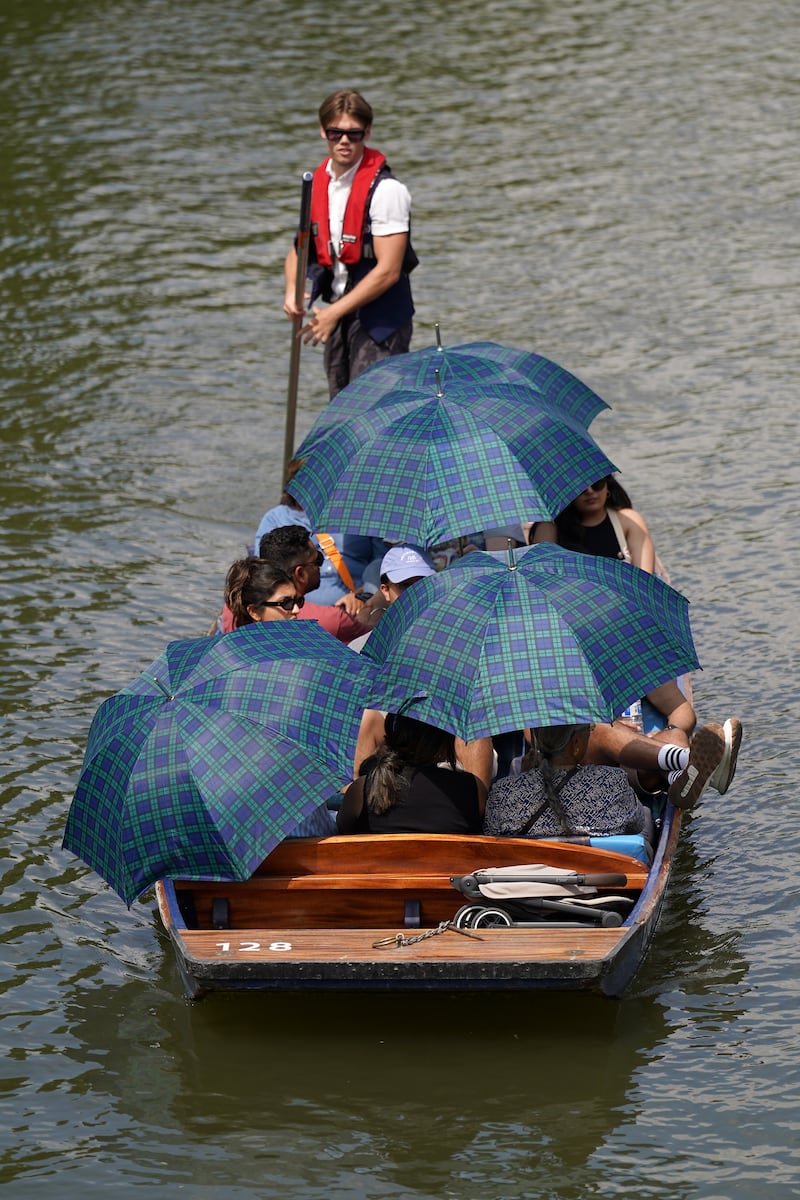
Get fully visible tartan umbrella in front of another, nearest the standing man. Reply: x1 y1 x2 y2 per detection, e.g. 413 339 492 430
291 376 615 546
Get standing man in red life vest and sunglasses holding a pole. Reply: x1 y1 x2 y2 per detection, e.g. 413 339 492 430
283 90 417 397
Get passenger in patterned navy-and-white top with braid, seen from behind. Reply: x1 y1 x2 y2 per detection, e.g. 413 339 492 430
483 725 654 841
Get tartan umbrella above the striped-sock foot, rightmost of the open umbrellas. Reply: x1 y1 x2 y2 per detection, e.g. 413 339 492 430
362 545 699 740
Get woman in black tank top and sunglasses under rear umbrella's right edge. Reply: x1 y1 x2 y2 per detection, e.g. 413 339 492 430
530 475 661 575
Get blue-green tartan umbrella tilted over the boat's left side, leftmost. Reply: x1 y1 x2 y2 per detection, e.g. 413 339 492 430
64 620 373 906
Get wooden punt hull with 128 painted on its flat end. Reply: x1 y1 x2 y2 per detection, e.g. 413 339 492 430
156 808 680 998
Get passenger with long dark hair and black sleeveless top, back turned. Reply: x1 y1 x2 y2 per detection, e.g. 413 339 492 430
336 713 486 833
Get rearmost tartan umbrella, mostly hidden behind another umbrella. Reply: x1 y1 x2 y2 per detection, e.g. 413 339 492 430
327 342 608 427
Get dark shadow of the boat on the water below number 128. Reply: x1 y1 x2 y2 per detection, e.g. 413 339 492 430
38 868 746 1196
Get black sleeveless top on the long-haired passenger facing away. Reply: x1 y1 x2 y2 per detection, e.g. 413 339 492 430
356 766 483 833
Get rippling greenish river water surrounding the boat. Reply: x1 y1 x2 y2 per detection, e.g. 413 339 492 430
0 0 800 1200
